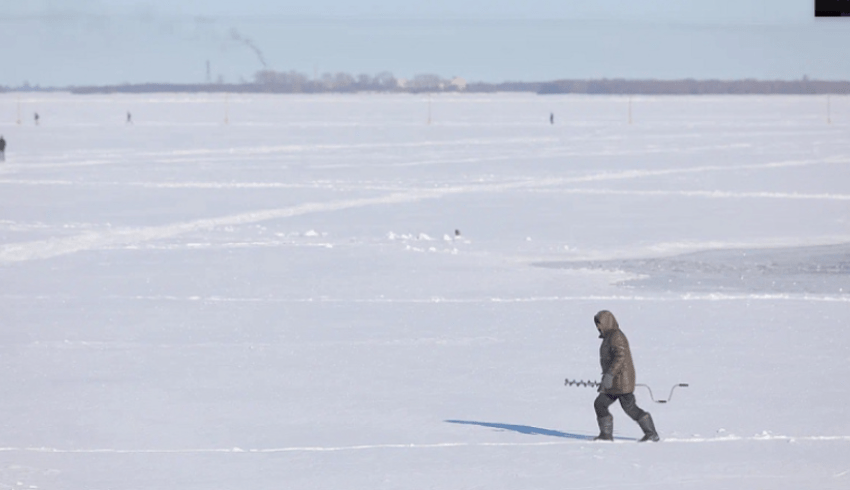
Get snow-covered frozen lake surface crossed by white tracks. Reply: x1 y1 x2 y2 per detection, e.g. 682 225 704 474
0 94 850 490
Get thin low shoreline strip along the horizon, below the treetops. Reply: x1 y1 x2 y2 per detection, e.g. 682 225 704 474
0 78 850 95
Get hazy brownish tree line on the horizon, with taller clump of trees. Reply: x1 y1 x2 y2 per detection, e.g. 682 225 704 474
31 70 850 95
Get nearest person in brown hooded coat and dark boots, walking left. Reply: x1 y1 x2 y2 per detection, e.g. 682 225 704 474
593 310 659 442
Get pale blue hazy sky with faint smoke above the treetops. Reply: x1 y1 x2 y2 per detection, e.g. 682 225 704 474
0 0 850 86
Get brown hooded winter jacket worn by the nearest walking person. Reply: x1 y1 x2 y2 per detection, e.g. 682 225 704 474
593 310 635 395
